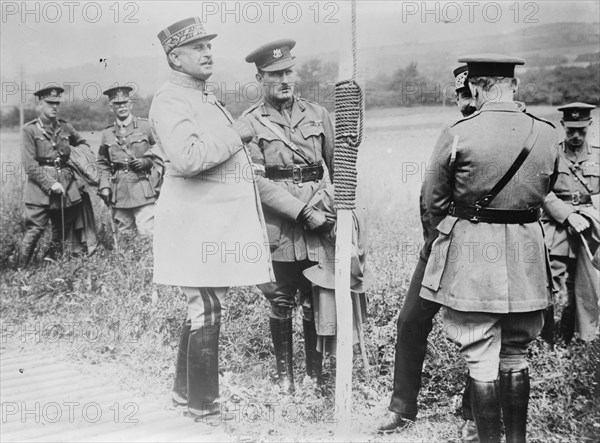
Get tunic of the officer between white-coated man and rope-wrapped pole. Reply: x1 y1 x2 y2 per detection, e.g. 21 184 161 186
241 97 335 262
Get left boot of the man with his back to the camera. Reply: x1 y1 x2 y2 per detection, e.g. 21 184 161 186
470 378 500 443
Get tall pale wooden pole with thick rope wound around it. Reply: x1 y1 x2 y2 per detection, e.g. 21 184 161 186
333 0 363 440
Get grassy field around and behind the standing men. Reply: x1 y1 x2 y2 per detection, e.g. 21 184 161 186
0 107 600 442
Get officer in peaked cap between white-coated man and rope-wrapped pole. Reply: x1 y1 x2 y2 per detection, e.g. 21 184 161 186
240 39 334 393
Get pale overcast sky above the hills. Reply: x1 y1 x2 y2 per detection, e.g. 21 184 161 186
0 0 600 78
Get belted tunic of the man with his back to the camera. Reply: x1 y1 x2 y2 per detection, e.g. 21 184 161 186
420 102 558 313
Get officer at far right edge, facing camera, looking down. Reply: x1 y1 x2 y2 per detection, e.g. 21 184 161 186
542 103 600 343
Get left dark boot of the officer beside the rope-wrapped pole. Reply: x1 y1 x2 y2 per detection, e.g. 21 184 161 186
269 318 296 394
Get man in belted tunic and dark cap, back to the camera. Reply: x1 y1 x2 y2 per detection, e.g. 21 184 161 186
420 55 558 442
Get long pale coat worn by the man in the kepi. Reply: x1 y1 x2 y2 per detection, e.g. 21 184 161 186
149 71 273 287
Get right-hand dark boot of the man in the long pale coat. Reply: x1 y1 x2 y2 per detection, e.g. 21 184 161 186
187 325 220 417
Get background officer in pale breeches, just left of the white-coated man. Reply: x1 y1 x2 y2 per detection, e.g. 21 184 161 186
98 86 162 236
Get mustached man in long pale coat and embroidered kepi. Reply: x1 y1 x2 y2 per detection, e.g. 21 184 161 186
149 17 273 418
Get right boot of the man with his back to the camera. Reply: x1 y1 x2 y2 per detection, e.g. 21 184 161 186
500 369 529 443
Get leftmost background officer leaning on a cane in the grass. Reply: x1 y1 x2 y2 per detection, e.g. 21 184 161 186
21 86 87 265
